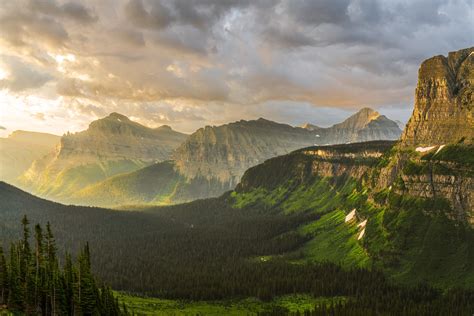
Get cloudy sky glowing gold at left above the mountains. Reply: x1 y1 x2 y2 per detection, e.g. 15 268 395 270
0 0 474 136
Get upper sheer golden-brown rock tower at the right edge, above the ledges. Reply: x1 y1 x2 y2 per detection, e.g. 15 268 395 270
401 47 474 146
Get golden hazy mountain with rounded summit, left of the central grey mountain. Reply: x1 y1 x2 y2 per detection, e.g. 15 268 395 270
20 113 187 200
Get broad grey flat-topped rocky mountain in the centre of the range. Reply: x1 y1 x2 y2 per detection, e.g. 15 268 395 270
174 119 316 189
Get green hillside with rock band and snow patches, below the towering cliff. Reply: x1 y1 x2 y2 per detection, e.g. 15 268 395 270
231 143 474 286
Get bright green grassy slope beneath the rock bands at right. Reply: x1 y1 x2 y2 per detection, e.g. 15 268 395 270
231 146 474 287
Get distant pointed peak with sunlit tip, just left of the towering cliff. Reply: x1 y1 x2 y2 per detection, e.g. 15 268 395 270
303 108 402 144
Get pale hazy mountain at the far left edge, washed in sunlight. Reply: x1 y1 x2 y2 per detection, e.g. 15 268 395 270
0 131 60 183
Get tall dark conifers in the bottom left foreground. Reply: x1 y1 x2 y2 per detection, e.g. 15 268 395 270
0 216 128 316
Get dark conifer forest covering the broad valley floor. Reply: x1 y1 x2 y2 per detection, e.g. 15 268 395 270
1 183 474 315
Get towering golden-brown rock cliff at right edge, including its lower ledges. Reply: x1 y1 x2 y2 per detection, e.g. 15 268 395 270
388 47 474 225
